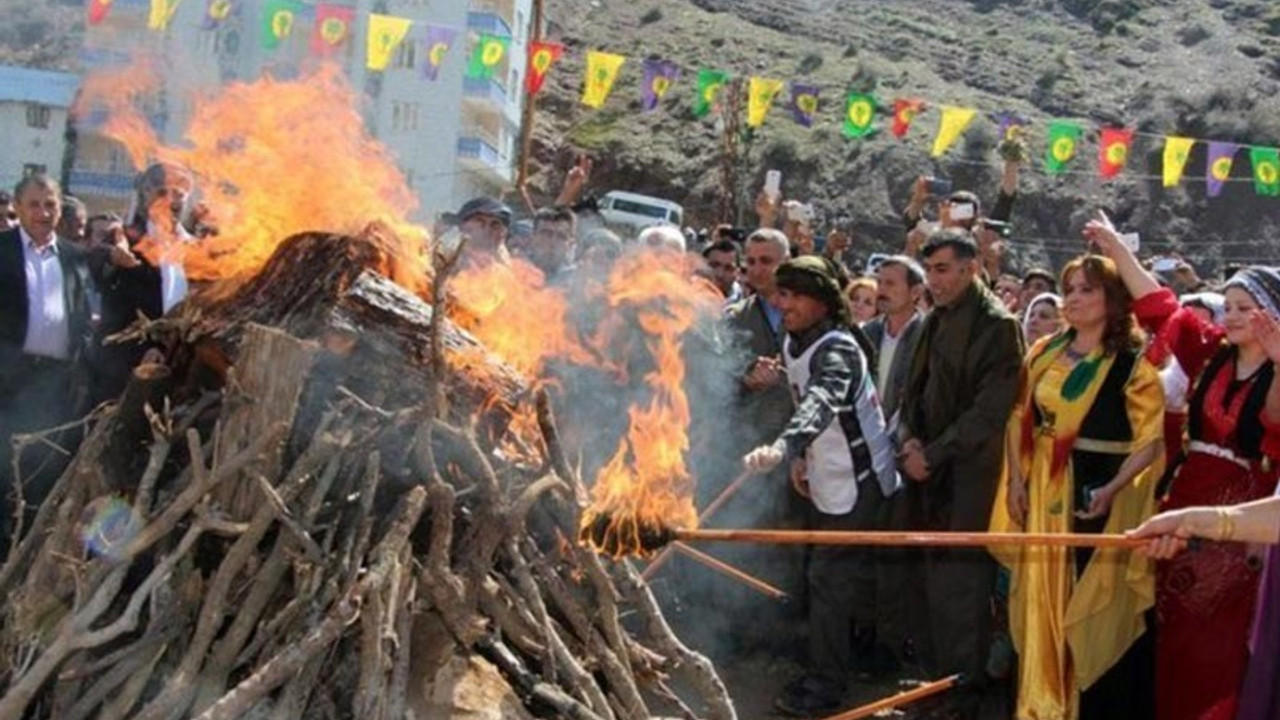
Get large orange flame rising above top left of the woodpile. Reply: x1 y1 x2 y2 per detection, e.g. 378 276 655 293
78 64 426 291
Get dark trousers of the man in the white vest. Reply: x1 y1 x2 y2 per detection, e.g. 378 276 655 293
806 480 881 691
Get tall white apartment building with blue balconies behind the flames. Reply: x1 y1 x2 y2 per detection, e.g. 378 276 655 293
70 0 531 222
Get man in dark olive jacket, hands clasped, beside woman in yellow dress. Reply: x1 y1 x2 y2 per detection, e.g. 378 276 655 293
900 228 1024 717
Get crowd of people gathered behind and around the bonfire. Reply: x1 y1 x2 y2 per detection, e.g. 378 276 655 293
0 147 1280 720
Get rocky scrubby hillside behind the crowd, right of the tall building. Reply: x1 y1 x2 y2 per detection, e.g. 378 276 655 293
527 0 1280 274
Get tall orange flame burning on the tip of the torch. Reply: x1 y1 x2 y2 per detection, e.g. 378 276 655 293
580 250 719 556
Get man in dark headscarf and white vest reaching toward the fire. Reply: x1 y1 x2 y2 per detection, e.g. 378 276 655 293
745 255 900 716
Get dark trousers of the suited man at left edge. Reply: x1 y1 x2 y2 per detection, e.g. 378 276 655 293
0 355 86 556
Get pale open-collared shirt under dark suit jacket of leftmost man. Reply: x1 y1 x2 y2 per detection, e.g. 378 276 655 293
18 228 70 360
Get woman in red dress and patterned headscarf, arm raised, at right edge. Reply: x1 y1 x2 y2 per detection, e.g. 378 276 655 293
1085 220 1280 720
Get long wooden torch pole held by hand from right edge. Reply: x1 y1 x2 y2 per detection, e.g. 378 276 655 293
675 529 1146 548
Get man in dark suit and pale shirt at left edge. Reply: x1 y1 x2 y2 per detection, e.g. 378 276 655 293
0 174 91 556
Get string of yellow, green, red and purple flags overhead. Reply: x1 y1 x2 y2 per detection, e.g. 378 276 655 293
88 0 1280 197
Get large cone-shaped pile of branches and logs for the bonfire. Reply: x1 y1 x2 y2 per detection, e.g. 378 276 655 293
0 229 735 720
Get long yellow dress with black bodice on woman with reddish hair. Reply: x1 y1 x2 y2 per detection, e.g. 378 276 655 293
991 331 1165 720
